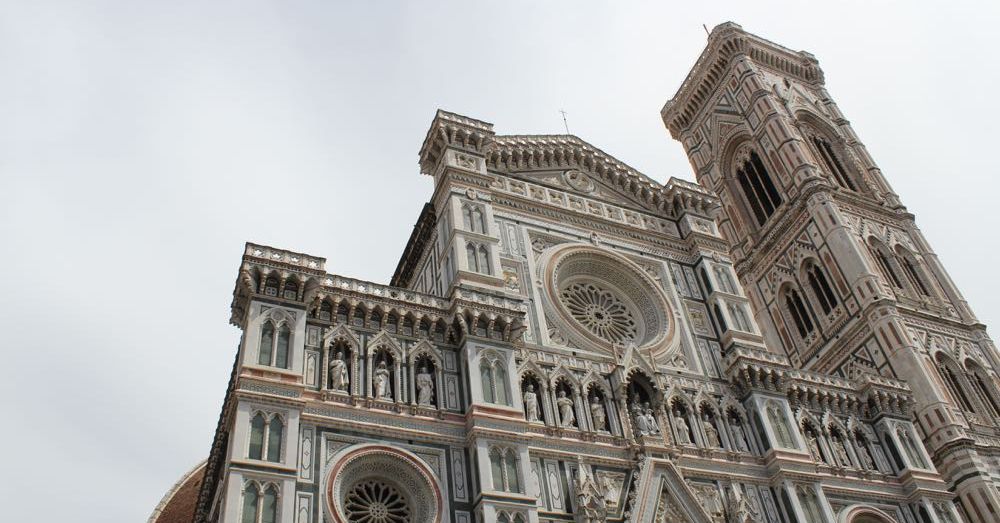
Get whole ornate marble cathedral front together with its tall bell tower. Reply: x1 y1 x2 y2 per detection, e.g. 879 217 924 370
176 23 1000 523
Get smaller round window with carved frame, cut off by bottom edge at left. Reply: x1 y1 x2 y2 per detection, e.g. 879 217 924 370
325 443 443 523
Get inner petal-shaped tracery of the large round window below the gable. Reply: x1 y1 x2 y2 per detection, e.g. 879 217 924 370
560 282 638 343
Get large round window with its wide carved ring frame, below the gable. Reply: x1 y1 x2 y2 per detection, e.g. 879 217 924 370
539 244 673 354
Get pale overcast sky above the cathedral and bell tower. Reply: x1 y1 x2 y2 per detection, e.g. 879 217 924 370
0 0 1000 522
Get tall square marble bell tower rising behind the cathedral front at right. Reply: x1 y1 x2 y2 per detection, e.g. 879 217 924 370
661 23 1000 522
